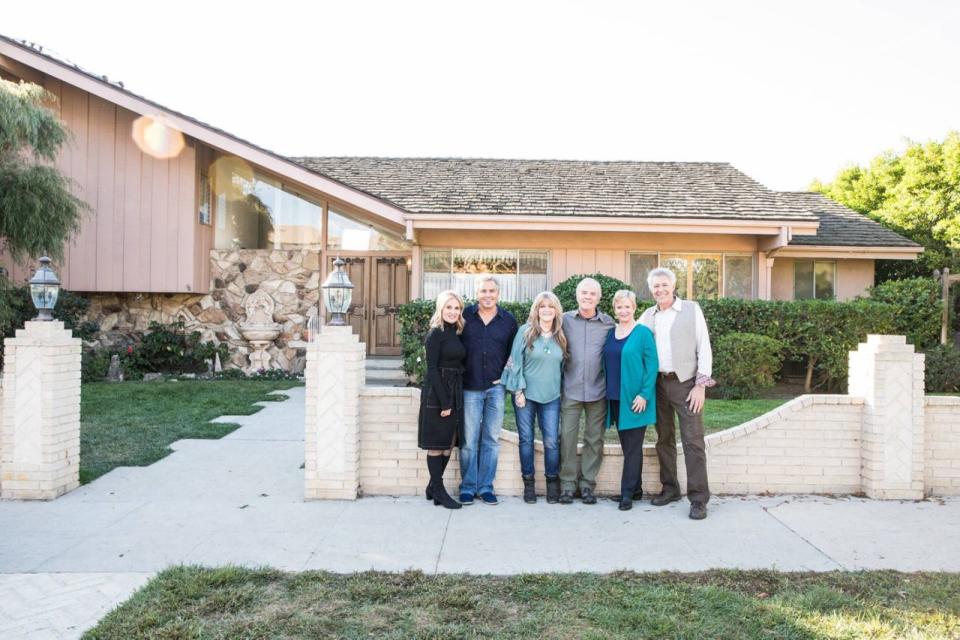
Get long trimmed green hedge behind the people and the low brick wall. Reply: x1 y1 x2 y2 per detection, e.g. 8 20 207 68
399 294 908 391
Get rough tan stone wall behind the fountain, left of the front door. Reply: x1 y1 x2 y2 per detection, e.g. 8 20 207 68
87 249 321 372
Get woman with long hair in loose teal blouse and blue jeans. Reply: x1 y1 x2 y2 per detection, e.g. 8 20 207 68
502 291 567 504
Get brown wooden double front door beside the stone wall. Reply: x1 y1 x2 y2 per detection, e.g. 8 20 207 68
327 256 410 356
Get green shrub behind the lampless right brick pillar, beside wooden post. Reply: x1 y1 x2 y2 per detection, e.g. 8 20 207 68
867 278 943 351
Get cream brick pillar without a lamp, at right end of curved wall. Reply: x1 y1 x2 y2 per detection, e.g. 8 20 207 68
848 335 924 500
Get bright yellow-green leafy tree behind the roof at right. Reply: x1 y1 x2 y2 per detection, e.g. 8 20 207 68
811 131 960 282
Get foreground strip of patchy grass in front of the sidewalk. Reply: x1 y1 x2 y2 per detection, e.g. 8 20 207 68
84 567 960 640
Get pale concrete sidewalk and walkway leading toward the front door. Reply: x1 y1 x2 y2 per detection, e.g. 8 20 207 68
0 388 960 638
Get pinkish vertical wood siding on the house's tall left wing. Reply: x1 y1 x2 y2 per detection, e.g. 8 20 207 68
0 78 202 293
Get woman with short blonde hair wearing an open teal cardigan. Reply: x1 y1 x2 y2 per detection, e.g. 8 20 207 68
603 289 660 511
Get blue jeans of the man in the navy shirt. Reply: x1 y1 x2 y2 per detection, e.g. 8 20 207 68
460 384 504 496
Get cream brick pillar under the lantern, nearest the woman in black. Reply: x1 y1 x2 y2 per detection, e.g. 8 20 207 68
304 326 366 500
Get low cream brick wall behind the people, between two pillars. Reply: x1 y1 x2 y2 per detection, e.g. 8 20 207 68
360 387 863 495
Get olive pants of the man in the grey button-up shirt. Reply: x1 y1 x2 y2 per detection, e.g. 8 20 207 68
560 398 607 492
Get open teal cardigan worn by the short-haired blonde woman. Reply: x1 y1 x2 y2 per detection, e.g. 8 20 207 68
607 322 660 431
